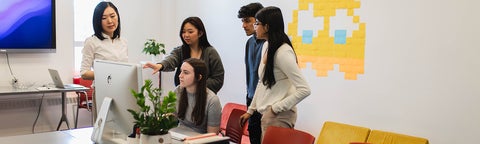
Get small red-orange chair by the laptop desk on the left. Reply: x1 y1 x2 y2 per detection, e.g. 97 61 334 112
75 79 94 128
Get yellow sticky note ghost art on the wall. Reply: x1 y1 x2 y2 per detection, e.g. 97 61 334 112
287 0 366 80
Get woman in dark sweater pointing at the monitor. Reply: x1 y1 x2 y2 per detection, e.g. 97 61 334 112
144 17 225 93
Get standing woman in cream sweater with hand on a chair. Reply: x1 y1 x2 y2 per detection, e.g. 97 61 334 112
240 7 310 140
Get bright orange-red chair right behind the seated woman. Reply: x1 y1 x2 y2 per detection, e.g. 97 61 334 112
220 103 250 144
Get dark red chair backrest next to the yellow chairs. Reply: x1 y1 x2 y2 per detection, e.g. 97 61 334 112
262 126 315 144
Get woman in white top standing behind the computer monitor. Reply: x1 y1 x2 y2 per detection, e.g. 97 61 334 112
80 2 128 80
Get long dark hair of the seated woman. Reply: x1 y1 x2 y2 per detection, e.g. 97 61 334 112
178 58 208 125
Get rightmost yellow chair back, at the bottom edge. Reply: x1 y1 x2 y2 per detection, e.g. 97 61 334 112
367 130 428 144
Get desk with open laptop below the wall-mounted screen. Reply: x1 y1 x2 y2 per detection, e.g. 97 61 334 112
0 86 89 131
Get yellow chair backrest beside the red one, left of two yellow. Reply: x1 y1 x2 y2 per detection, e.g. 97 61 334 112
317 121 370 144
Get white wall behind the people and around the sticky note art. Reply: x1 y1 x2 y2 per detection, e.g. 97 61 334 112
0 0 480 144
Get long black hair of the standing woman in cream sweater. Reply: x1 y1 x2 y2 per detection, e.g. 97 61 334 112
255 6 293 88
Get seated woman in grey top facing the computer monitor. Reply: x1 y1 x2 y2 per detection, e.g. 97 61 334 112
175 58 222 133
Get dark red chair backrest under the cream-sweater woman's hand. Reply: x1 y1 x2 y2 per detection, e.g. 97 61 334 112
225 109 247 143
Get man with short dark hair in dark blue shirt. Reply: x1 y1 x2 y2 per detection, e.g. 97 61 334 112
238 3 265 144
